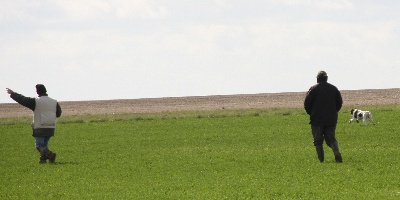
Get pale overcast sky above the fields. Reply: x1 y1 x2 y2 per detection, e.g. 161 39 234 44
0 0 400 103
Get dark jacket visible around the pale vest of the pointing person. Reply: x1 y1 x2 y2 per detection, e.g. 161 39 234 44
10 92 62 137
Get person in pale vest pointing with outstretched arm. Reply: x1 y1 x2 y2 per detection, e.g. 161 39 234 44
7 84 61 164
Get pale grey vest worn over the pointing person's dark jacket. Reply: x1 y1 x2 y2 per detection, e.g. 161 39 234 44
32 96 57 129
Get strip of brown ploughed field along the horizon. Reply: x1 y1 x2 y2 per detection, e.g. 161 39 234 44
0 88 400 118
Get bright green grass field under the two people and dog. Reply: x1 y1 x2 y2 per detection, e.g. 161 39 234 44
0 105 400 199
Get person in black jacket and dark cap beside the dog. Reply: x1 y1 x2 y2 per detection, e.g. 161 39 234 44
304 71 343 163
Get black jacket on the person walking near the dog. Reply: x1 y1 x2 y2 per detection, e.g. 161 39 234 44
304 82 343 126
